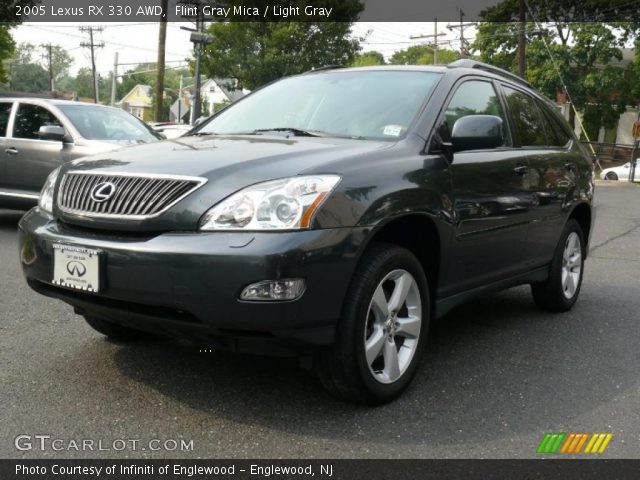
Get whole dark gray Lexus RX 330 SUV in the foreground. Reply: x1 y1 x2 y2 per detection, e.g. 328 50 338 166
20 60 594 404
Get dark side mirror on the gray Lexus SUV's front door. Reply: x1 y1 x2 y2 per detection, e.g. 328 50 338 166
451 115 504 152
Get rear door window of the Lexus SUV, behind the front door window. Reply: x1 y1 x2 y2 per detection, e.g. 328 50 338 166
503 86 548 147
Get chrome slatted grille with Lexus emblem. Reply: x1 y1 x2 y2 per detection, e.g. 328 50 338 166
57 172 207 220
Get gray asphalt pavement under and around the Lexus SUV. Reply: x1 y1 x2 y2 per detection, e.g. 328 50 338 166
0 182 640 458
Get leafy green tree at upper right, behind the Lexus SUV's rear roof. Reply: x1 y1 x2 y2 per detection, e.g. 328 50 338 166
472 0 638 137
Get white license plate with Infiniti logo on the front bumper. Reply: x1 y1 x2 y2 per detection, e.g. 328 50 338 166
52 244 100 292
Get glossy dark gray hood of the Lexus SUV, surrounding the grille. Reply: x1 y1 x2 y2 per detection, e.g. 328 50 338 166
58 135 393 231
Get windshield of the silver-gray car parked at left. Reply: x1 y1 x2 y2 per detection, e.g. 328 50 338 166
59 105 161 143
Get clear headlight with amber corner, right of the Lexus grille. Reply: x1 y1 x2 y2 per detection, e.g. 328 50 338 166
200 175 340 230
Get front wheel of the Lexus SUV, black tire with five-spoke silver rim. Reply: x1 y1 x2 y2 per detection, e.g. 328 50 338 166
314 243 430 405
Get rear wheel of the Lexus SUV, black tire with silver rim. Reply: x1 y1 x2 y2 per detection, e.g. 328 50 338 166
531 219 585 312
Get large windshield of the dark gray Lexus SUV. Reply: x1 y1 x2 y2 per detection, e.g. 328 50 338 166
196 70 440 140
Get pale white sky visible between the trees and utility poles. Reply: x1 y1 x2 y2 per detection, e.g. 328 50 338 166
13 22 470 76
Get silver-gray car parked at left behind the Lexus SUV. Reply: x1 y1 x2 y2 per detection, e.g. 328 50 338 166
0 98 161 208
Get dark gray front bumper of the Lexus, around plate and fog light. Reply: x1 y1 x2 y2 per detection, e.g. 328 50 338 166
19 208 366 353
